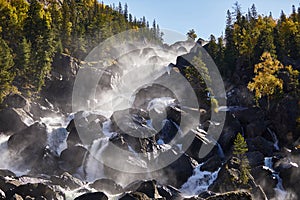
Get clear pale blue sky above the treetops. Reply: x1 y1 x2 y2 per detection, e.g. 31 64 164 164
103 0 300 39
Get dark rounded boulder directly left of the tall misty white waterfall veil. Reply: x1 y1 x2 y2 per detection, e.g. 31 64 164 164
59 146 88 173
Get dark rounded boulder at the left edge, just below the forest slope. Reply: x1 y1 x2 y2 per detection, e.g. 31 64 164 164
0 108 27 133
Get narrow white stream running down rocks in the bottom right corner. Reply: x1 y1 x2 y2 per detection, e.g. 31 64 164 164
264 157 287 200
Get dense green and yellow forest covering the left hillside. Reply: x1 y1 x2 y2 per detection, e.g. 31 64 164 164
0 0 162 102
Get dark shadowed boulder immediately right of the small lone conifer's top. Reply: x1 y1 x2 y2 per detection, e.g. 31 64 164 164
246 136 274 157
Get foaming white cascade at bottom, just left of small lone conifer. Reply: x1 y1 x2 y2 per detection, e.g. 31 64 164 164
180 163 220 197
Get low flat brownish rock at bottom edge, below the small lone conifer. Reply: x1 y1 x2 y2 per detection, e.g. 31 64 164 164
206 191 252 200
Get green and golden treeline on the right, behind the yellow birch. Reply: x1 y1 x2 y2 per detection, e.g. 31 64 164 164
206 2 300 78
